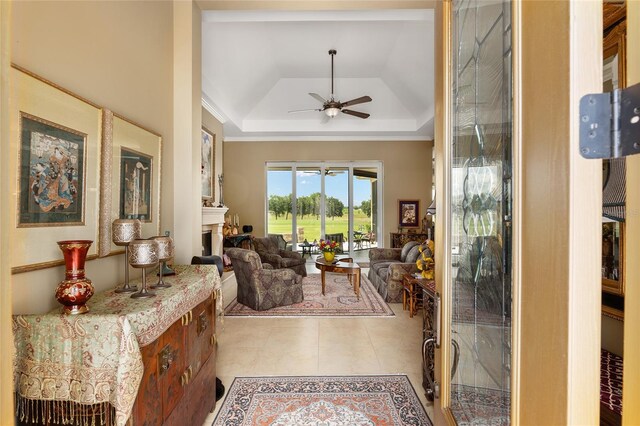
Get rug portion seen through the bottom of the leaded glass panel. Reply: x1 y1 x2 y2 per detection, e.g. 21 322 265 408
451 384 510 426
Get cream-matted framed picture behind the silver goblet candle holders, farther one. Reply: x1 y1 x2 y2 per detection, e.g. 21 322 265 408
99 109 162 256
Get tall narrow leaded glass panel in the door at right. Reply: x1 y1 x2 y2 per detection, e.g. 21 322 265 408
449 0 512 425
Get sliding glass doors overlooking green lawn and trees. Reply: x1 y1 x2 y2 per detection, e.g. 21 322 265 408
266 162 382 259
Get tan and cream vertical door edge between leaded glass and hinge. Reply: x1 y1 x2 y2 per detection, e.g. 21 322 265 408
514 0 602 424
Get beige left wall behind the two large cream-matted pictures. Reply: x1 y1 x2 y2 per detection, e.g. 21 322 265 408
10 1 173 314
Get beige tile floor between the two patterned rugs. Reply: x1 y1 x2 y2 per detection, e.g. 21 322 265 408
204 261 433 426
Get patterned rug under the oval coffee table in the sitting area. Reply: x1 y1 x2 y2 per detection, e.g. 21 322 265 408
225 274 394 317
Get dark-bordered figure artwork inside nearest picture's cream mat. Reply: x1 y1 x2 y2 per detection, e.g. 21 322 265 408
18 112 87 227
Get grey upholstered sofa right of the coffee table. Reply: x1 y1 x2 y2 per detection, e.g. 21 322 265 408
367 241 429 302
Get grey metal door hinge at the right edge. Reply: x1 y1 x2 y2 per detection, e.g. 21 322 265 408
580 83 640 158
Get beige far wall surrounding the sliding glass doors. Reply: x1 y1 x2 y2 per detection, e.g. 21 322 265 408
223 141 433 247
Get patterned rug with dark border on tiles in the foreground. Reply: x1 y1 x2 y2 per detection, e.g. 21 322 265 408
212 375 432 426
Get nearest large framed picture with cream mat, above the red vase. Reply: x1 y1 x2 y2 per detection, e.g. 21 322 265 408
7 65 102 274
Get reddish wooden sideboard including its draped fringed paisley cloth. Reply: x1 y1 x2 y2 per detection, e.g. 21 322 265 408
13 265 220 426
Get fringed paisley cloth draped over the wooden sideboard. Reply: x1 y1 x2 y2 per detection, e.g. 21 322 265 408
13 265 220 426
